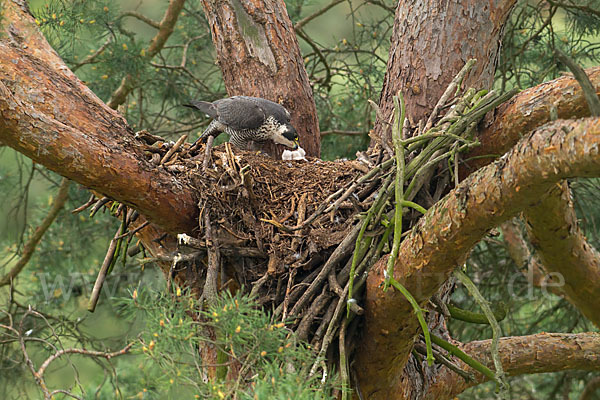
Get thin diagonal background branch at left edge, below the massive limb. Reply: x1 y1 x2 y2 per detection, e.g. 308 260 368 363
0 178 70 287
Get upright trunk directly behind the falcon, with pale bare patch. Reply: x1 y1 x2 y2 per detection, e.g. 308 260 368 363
202 0 321 158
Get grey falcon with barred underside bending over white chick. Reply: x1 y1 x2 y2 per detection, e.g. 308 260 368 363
186 96 298 150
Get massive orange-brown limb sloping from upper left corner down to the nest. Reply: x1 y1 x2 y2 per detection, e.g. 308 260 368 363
0 1 197 232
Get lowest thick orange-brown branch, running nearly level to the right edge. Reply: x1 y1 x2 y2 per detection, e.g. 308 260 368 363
424 333 600 400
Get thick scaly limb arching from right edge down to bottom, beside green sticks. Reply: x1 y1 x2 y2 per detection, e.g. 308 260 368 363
356 118 600 399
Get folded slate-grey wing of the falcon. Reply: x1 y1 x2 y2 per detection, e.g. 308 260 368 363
213 96 266 130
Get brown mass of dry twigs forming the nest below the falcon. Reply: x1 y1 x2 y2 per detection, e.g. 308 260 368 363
189 144 362 274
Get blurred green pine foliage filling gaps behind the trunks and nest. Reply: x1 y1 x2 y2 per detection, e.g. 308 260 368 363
0 0 600 399
